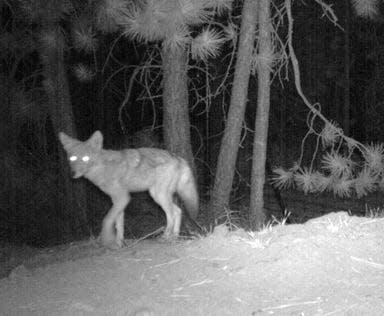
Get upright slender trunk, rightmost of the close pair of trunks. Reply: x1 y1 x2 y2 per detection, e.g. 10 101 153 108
249 0 273 229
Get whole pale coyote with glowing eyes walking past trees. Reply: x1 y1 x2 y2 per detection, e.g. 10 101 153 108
59 131 199 248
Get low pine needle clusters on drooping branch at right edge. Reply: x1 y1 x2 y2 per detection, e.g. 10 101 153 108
272 123 384 198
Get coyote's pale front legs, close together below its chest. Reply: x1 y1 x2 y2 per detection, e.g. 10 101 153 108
100 193 130 249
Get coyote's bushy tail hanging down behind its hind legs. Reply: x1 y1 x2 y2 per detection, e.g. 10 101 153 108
177 164 199 220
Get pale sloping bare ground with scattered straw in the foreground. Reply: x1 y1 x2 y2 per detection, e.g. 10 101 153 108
0 191 384 316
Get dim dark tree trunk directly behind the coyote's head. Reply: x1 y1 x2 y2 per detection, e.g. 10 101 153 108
40 25 88 239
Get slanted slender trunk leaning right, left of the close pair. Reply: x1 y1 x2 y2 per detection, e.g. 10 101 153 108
210 0 258 219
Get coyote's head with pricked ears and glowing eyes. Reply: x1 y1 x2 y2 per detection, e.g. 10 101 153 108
59 131 103 178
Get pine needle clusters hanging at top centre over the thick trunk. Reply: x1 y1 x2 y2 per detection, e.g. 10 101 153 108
96 0 233 60
